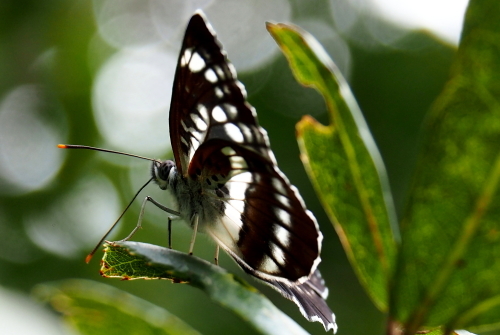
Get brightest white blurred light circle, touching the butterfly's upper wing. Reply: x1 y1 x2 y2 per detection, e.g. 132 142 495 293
92 48 177 156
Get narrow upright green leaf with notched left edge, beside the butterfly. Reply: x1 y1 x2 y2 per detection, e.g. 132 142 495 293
267 23 397 311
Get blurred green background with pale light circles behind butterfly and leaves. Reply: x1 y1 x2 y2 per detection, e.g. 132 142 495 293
0 0 484 334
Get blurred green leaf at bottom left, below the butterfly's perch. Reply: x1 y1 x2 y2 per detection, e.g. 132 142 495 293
35 279 200 335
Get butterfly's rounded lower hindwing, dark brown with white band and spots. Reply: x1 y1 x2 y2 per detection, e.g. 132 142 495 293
191 139 322 282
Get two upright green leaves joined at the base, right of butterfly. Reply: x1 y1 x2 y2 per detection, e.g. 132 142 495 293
270 1 500 334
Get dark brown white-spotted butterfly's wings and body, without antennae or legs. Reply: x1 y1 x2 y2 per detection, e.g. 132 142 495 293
152 11 337 332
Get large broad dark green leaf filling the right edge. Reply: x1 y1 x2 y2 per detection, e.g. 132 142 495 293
390 0 500 332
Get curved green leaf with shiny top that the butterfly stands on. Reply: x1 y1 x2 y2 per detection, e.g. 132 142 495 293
101 242 307 334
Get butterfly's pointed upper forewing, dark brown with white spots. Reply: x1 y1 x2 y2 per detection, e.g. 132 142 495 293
170 15 268 176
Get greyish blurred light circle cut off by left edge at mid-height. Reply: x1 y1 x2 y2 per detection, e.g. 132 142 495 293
0 85 65 194
